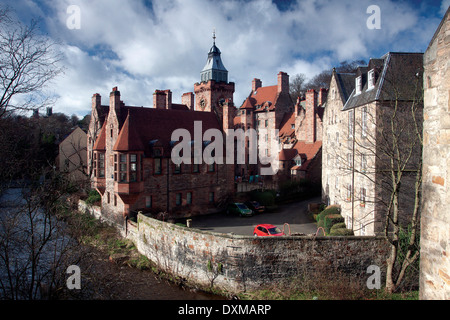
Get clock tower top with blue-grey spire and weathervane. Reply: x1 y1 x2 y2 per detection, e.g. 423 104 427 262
194 31 234 121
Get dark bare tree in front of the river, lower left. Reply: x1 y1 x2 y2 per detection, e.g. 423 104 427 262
0 172 79 300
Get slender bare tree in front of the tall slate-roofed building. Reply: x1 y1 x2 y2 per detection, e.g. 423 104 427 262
330 72 423 292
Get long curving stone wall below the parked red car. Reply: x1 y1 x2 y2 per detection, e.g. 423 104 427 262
127 214 389 293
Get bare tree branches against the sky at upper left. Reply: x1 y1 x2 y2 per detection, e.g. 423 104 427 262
0 7 62 118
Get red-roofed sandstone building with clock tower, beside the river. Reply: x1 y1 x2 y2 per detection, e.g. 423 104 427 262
87 37 235 225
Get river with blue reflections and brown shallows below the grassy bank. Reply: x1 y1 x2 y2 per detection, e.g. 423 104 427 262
0 188 225 300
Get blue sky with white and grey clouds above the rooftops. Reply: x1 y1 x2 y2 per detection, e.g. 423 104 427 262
0 0 450 117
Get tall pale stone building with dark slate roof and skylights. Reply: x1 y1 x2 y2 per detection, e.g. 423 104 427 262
322 52 423 235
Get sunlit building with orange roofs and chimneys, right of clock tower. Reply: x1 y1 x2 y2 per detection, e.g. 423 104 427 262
234 71 327 184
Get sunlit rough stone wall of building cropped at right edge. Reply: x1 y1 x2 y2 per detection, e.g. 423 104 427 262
420 9 450 300
